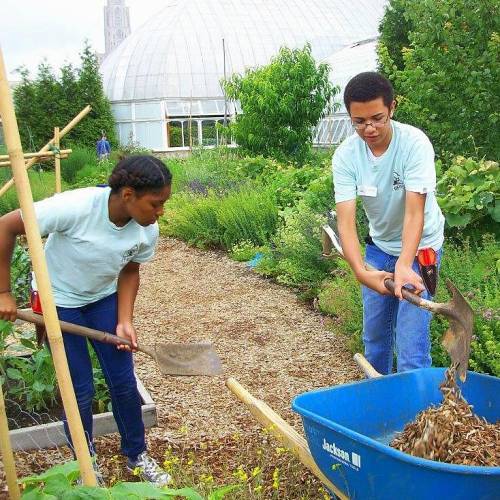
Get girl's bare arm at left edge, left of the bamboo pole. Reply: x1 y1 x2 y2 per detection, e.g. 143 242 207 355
0 210 25 321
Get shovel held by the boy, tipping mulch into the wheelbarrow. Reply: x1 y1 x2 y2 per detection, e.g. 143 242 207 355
322 212 474 382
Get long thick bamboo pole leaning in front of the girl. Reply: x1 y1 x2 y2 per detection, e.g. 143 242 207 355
0 49 96 486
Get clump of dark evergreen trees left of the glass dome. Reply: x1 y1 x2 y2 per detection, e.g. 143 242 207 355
14 43 116 150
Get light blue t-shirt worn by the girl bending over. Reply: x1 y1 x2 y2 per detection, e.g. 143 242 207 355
30 187 159 307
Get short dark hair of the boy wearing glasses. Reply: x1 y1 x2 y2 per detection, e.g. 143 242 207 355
344 71 394 113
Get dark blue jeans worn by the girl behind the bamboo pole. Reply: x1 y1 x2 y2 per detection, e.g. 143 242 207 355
57 293 146 461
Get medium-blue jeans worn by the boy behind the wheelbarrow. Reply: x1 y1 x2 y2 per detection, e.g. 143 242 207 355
362 244 442 375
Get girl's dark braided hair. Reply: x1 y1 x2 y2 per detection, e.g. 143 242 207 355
108 155 172 194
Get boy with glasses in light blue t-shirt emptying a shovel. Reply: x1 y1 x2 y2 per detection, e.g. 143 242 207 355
332 72 444 374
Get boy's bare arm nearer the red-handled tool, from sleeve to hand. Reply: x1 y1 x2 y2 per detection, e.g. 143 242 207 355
394 191 427 299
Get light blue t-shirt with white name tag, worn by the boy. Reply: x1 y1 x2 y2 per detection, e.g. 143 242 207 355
332 121 444 256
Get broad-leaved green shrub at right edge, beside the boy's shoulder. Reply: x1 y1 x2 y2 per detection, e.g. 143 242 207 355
437 156 500 238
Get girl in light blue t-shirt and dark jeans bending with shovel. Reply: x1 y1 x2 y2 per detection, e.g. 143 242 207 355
0 156 172 486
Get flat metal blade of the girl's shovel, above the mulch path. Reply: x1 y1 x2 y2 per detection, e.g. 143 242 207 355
155 343 222 377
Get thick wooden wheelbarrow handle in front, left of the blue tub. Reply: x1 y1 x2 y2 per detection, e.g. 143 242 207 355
226 377 348 500
